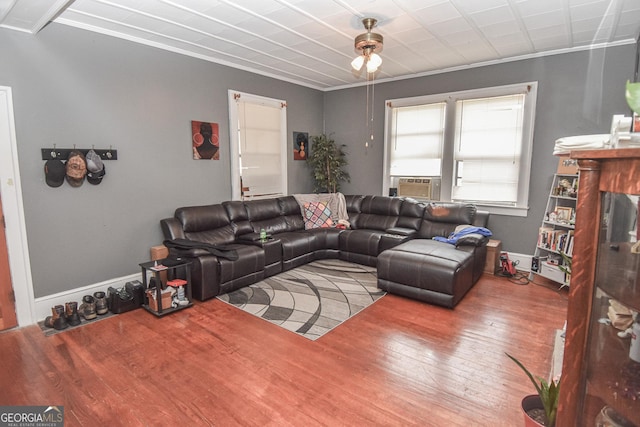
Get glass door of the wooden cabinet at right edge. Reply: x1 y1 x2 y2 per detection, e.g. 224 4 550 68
577 193 640 427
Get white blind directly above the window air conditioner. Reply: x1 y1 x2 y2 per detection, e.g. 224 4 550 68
390 102 446 176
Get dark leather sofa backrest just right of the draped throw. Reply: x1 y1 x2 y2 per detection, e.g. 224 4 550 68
347 196 402 231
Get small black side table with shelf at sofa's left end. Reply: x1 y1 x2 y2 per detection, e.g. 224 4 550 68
139 258 193 317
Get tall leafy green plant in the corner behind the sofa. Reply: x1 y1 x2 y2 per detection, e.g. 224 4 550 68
307 134 351 193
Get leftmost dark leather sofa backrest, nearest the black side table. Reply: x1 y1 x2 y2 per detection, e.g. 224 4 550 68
174 205 235 245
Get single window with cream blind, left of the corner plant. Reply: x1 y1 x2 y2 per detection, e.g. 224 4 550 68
229 91 287 200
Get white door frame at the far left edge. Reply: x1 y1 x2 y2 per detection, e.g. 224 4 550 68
0 86 35 326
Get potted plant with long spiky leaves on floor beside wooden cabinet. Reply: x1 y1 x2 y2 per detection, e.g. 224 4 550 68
506 353 560 427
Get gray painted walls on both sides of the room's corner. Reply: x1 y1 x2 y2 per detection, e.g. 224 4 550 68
0 20 635 297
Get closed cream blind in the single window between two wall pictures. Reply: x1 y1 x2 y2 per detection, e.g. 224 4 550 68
238 102 284 198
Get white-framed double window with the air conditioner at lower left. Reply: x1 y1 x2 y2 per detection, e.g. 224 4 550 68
383 82 537 216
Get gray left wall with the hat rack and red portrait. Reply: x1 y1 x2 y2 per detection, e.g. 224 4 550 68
0 24 323 297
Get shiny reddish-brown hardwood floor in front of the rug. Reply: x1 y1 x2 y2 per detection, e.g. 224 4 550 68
0 275 567 427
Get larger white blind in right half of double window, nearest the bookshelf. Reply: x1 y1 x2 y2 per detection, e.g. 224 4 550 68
452 94 525 206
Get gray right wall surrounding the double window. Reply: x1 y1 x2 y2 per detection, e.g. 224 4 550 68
324 45 635 254
